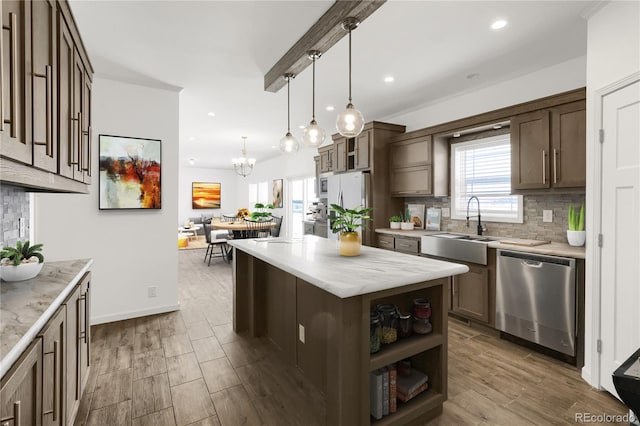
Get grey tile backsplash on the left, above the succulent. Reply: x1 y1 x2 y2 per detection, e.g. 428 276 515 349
0 184 29 247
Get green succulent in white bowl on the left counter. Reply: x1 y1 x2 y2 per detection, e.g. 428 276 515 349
0 240 44 281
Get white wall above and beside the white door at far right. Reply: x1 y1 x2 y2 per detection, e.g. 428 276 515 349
582 1 640 386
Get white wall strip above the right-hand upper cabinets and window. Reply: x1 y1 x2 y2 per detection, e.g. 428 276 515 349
376 56 586 132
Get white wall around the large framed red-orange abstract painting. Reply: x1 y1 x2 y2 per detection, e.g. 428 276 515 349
34 77 179 324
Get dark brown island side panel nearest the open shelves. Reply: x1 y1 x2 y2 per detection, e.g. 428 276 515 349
296 279 362 425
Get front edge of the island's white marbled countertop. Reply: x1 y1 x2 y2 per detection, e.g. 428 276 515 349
229 240 469 299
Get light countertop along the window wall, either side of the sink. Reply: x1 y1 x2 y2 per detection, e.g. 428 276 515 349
375 228 585 259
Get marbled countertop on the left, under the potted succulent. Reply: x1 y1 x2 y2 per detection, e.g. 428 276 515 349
0 259 93 377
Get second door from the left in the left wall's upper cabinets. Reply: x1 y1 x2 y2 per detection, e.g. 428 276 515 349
31 0 58 173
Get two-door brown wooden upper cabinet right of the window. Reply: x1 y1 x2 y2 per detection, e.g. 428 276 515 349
511 101 586 191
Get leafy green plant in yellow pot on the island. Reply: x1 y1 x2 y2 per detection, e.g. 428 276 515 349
330 204 372 256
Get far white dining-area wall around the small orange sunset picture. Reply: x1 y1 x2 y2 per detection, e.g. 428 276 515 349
178 166 242 225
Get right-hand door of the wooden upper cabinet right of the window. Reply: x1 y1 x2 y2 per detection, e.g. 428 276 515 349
551 101 587 188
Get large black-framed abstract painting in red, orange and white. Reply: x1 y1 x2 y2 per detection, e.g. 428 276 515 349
99 135 161 210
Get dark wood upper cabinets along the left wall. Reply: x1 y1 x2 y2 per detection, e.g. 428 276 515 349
0 0 93 193
